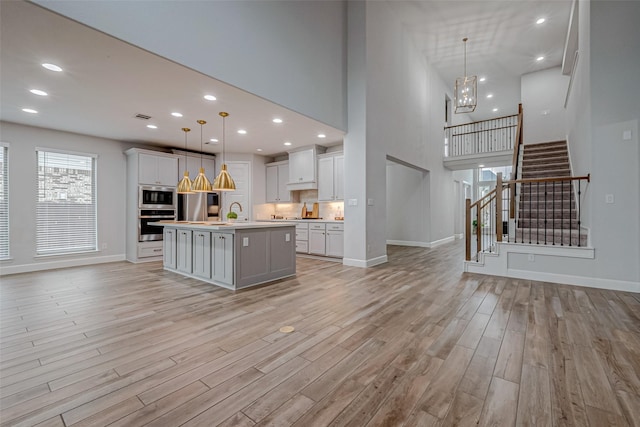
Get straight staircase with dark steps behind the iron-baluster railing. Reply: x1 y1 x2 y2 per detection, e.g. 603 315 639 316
515 141 588 246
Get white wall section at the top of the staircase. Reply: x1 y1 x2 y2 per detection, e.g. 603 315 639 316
520 67 569 144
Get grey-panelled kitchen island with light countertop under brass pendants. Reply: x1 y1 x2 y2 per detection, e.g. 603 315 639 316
153 221 296 290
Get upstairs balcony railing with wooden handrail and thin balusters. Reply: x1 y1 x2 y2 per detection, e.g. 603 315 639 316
444 105 522 159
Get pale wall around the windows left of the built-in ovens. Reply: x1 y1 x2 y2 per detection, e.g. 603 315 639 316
0 122 128 274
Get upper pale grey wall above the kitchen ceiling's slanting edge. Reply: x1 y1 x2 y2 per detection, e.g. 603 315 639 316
35 0 346 130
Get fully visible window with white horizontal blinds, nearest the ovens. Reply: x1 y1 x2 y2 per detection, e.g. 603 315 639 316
36 150 97 255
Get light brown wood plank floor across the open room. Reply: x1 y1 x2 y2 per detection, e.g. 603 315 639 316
0 242 640 427
